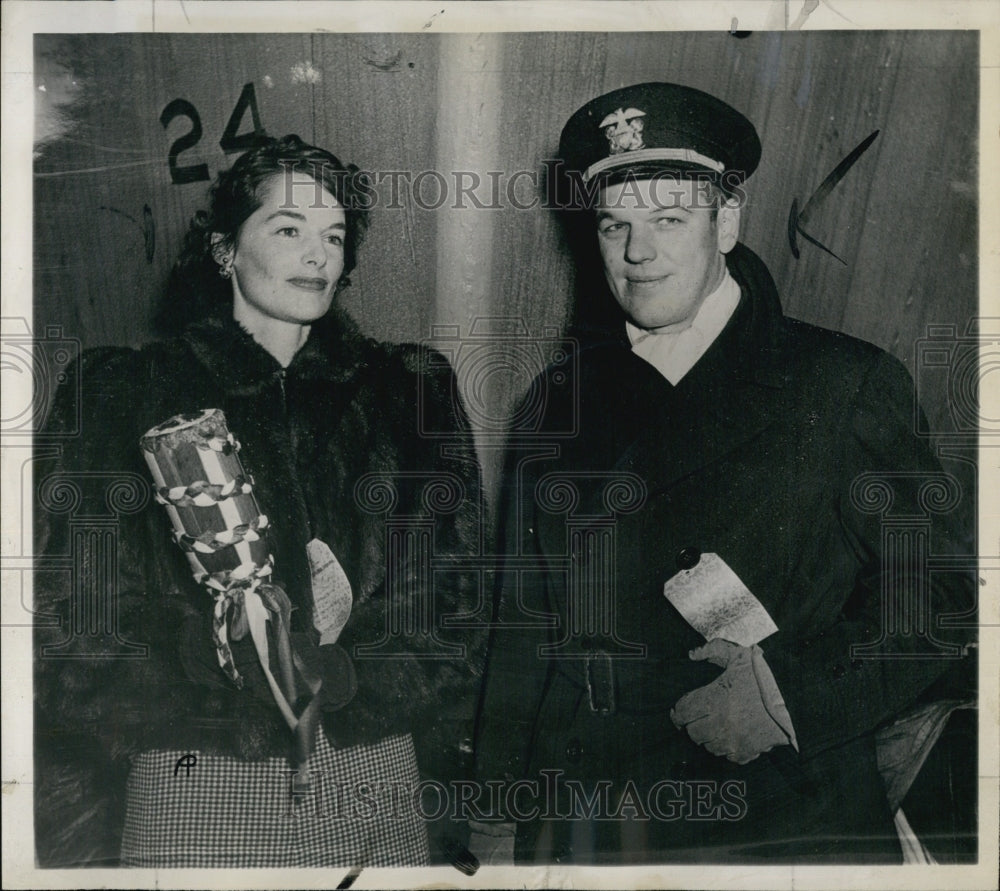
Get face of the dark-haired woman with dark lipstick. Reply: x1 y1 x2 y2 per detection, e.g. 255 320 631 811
229 171 347 325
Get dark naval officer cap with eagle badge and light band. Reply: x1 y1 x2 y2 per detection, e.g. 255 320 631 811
559 83 760 199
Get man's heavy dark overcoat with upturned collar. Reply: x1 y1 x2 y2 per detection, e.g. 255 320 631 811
476 245 975 863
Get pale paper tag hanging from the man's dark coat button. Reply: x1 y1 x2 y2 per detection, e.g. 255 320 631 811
663 554 778 647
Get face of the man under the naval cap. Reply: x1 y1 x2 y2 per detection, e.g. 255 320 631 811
597 179 739 331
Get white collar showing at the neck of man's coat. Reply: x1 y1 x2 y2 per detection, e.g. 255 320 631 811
625 270 740 385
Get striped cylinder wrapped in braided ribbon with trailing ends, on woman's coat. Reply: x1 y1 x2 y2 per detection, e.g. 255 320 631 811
140 409 322 787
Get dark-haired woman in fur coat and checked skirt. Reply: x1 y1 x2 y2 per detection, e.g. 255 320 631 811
36 136 488 866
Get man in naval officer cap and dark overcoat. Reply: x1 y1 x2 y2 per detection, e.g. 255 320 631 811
477 83 974 863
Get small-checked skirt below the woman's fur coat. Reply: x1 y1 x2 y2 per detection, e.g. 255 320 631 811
121 732 428 868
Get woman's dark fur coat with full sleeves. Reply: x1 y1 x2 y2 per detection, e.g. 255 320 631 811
35 313 481 866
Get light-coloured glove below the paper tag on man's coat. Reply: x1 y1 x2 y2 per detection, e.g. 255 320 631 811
670 639 795 764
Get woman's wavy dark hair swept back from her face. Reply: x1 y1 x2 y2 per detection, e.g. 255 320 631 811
155 135 371 334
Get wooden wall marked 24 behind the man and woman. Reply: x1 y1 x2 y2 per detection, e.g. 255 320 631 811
34 32 979 494
